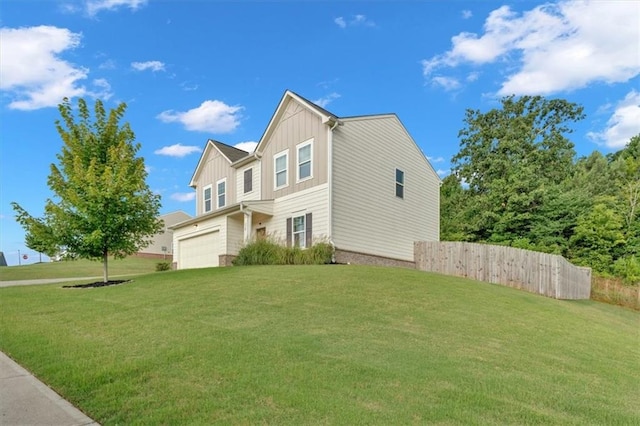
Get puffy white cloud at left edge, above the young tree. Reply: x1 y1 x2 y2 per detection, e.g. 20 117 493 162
0 26 111 110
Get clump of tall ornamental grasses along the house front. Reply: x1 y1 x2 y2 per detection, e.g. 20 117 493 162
233 238 333 266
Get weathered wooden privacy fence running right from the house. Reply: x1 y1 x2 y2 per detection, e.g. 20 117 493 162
414 241 591 299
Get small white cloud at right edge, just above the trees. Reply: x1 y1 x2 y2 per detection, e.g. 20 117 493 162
588 90 640 149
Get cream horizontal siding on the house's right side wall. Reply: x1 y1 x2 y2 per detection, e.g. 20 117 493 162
331 115 440 261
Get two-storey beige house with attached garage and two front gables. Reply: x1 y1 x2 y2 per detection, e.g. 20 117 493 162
172 91 440 269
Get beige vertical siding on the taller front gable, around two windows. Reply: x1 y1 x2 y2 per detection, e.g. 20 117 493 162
261 99 327 200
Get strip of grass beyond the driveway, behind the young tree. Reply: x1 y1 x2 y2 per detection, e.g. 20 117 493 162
0 257 161 281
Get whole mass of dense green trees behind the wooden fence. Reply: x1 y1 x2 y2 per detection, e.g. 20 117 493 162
441 96 640 282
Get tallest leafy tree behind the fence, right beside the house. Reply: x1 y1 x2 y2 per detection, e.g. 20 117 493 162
452 96 584 245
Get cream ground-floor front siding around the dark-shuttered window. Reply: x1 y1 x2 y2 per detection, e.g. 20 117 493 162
253 184 329 244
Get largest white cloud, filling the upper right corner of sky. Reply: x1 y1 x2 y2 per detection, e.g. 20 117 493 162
422 0 640 95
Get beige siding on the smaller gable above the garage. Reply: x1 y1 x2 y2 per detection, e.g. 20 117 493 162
194 149 236 216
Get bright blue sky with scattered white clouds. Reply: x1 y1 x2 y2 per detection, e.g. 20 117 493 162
0 0 640 265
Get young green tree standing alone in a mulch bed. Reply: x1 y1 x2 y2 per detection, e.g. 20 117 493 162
12 98 162 282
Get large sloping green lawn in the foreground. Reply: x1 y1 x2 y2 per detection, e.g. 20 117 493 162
0 265 640 425
